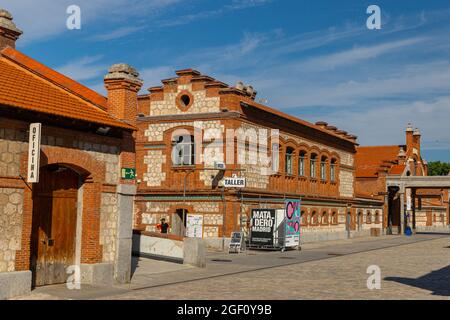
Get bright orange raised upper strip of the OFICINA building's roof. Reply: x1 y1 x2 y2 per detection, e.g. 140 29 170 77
0 47 107 111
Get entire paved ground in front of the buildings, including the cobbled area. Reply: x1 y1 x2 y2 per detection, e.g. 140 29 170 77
14 234 450 300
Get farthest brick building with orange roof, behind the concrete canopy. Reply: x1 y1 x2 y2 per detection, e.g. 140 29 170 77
356 125 449 233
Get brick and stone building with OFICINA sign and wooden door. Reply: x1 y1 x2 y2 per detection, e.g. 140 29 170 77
0 10 142 298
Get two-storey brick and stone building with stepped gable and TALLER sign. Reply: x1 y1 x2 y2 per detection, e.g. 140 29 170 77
135 69 383 244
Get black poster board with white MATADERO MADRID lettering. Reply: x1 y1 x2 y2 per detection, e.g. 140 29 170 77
250 209 276 246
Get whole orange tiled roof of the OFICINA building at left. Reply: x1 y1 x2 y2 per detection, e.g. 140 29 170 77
0 47 135 130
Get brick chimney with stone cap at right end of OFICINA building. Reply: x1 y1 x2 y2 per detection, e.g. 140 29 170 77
105 63 143 125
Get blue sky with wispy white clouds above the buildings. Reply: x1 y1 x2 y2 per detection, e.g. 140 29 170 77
0 0 450 162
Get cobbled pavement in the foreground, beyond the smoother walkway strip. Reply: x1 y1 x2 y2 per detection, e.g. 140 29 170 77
106 238 450 300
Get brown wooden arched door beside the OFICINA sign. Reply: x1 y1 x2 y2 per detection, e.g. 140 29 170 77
31 164 81 286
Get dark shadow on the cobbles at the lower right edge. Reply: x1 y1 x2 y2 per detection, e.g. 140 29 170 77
384 266 450 296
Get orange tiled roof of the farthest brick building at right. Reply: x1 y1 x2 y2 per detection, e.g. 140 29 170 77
355 146 401 178
